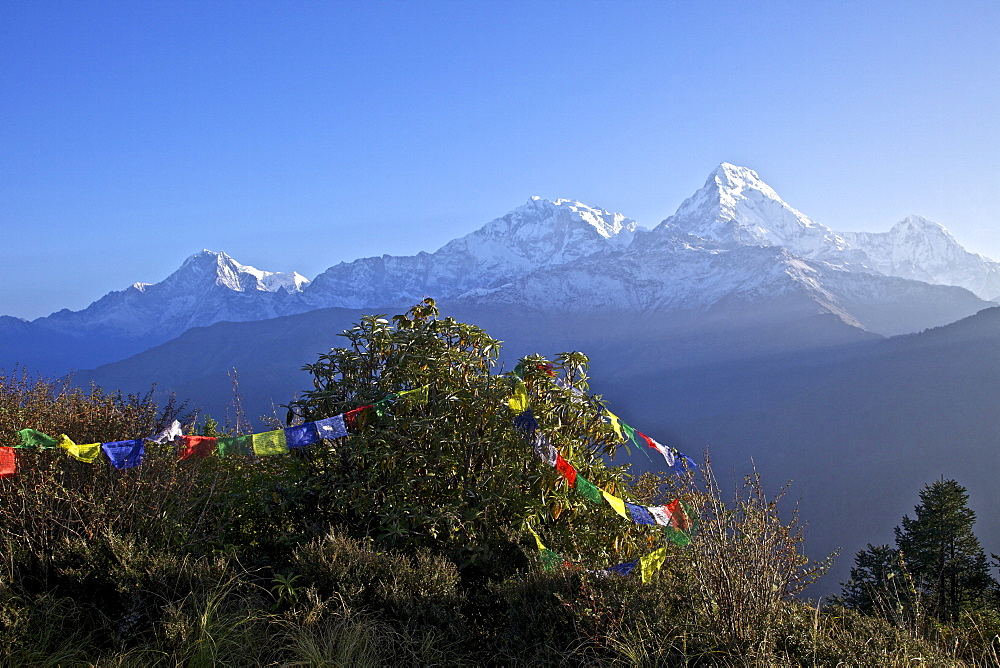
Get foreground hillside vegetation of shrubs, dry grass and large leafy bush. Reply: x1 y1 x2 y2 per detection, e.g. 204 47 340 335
0 302 1000 666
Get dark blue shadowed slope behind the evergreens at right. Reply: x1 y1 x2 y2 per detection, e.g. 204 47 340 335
608 308 1000 590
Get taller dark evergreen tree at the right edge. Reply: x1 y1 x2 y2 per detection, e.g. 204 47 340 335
895 480 996 619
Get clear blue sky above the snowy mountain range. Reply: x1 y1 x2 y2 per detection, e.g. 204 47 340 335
0 0 1000 318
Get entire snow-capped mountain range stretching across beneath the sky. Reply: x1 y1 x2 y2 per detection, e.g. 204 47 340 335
0 163 1000 374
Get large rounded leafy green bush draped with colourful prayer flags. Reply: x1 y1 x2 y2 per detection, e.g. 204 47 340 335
288 299 663 569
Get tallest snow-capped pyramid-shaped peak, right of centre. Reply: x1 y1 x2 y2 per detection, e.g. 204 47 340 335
657 162 847 258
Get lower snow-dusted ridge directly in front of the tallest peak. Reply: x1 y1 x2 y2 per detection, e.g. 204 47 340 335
456 230 989 336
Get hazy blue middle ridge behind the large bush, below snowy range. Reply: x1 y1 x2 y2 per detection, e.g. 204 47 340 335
74 304 873 416
